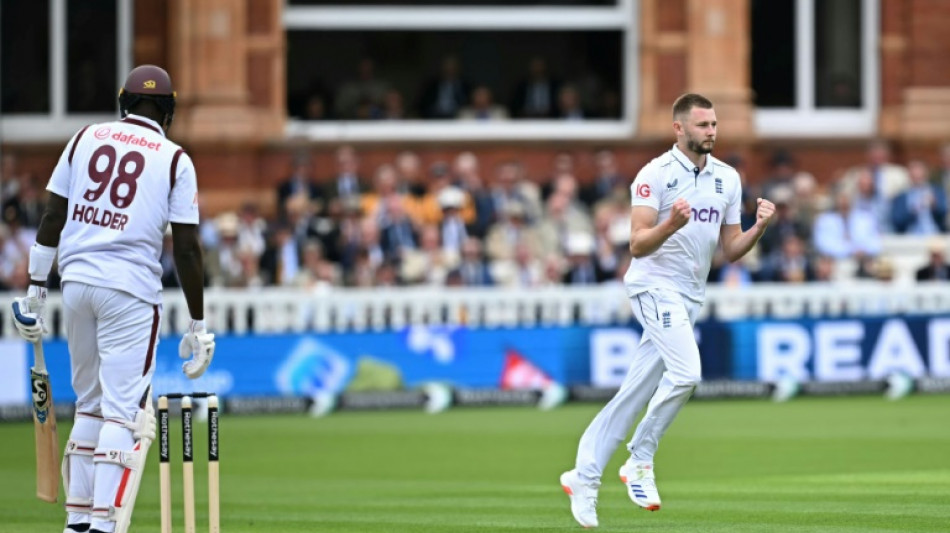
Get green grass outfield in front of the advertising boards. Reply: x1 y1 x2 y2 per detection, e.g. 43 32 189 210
0 396 950 533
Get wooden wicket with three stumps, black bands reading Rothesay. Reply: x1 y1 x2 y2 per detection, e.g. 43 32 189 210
158 392 221 533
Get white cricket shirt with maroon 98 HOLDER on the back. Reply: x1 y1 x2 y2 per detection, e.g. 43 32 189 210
46 115 198 304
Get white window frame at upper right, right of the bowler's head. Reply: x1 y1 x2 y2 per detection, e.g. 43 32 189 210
754 0 881 138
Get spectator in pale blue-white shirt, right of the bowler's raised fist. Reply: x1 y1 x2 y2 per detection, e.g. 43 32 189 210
812 191 881 259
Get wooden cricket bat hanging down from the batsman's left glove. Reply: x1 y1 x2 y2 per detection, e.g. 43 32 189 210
30 341 60 503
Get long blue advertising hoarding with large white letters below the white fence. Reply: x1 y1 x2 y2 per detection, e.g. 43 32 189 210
0 316 950 403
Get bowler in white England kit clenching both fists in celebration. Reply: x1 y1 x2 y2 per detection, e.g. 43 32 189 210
561 94 775 527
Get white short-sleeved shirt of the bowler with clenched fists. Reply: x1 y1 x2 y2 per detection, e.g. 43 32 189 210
623 145 742 302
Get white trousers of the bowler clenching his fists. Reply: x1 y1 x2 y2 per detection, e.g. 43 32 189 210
576 289 702 484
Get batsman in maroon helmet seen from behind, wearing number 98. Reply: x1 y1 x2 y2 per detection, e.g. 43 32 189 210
14 65 214 533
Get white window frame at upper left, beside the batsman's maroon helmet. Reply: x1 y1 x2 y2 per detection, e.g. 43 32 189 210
0 0 134 142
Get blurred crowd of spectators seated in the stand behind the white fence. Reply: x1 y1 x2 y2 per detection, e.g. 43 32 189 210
0 142 950 290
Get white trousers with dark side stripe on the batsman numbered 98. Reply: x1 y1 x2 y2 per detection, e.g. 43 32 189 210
63 282 161 532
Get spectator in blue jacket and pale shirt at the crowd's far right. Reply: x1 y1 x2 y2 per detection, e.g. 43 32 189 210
891 160 947 235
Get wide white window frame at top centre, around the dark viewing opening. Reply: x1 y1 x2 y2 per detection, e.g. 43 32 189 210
283 0 639 142
